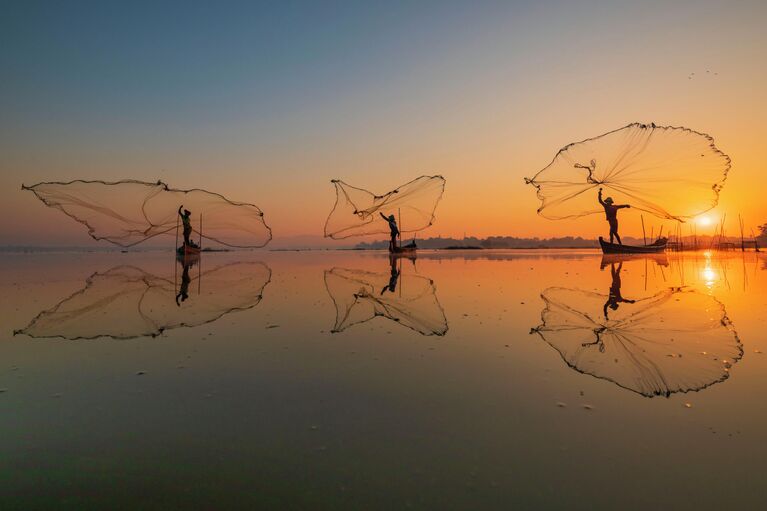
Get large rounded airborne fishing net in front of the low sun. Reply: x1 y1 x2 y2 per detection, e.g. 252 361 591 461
526 123 730 220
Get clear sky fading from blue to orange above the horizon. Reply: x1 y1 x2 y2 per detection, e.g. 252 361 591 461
0 0 767 246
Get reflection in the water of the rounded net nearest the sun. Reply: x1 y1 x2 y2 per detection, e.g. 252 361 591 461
533 287 743 397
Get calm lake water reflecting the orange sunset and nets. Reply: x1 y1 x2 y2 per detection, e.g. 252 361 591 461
0 251 767 510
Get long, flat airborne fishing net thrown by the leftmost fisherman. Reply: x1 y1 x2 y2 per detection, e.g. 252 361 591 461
23 181 272 248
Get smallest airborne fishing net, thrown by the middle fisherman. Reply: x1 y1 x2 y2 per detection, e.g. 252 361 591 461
325 176 445 239
